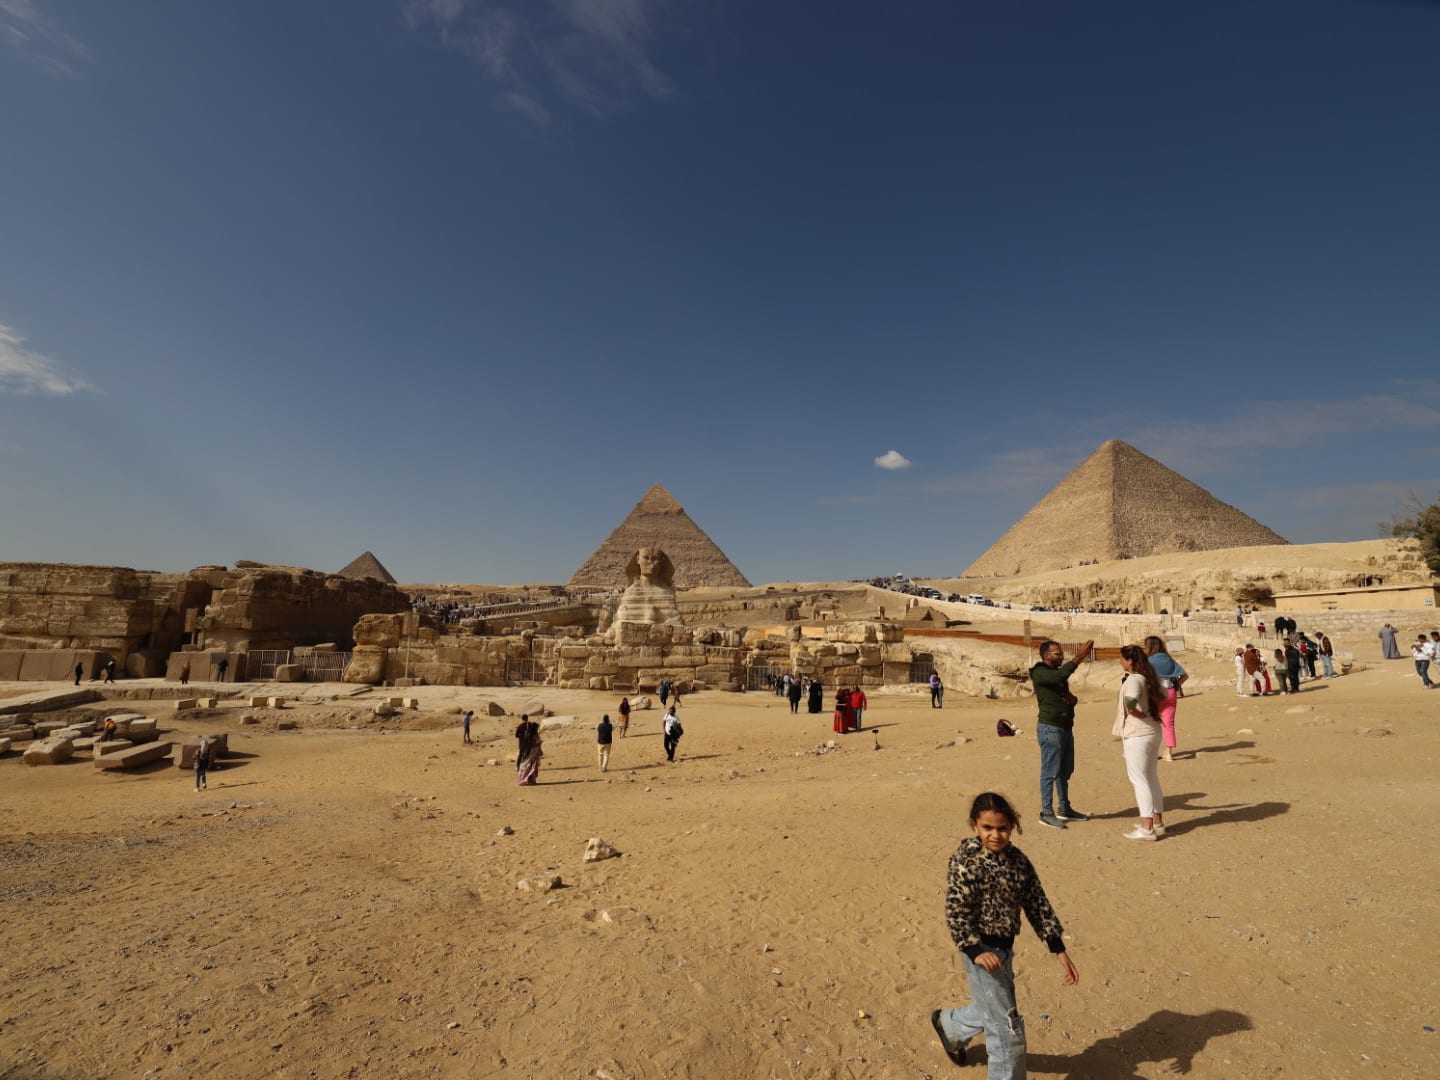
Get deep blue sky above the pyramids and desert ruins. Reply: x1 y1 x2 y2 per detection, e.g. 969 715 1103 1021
0 0 1440 582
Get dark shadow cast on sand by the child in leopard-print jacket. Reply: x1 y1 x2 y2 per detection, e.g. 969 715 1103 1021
1028 1009 1253 1080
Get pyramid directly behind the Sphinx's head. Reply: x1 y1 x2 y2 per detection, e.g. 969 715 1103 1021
570 484 750 589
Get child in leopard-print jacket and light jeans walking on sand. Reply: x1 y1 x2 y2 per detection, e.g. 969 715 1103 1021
930 792 1080 1080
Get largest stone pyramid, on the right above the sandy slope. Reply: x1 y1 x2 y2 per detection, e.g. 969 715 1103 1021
963 439 1289 577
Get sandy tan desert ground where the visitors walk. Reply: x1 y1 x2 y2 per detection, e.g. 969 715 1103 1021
0 657 1440 1080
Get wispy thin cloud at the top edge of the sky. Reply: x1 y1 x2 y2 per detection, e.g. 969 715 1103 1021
406 0 674 127
